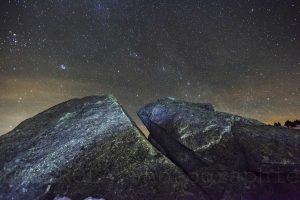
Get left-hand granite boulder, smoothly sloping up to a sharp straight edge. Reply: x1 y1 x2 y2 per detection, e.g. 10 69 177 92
0 96 206 200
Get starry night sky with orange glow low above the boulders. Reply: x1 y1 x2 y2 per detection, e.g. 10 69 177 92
0 0 300 134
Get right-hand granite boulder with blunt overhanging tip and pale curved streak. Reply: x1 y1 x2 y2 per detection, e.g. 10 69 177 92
138 98 300 200
